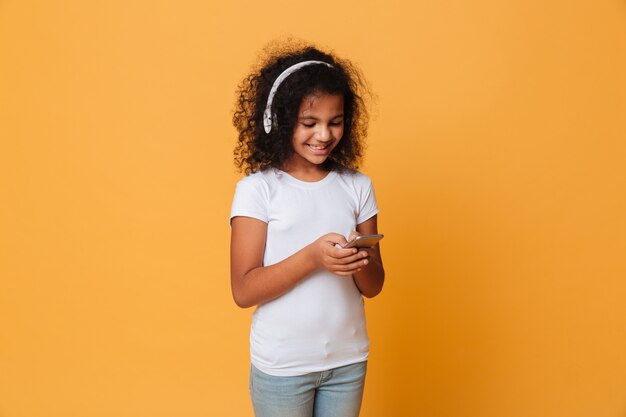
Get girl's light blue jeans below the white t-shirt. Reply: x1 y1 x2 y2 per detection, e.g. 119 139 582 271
250 361 367 417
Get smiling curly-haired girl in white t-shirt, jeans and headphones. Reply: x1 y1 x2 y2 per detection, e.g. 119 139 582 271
230 41 385 417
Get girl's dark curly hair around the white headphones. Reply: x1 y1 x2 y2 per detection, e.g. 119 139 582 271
233 43 371 174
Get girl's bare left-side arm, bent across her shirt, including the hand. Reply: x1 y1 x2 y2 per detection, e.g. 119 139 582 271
230 216 365 308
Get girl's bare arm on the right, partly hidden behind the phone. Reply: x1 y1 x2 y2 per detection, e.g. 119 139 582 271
350 216 385 298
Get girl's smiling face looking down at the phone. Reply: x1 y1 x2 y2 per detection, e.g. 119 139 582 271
286 93 344 172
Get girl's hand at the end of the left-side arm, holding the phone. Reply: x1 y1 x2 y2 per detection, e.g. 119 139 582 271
310 233 369 276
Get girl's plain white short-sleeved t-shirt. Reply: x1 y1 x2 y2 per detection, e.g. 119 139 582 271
230 168 378 376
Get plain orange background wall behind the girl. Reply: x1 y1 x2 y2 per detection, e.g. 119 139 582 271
0 0 626 417
